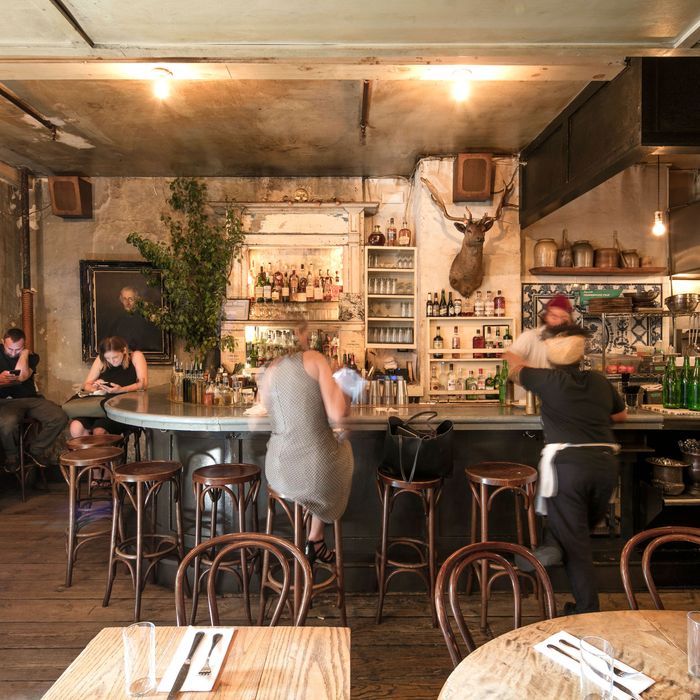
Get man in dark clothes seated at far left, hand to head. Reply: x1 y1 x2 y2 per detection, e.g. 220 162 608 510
0 328 68 471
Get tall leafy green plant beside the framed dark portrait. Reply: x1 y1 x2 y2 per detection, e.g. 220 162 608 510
126 177 245 359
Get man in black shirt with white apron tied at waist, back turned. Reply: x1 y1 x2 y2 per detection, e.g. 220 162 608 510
514 326 627 613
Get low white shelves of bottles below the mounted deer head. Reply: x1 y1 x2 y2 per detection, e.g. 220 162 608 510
425 316 515 402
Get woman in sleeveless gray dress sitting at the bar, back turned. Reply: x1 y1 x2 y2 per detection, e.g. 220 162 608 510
261 324 353 564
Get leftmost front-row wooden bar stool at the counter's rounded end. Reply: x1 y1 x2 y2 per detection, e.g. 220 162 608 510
59 446 124 588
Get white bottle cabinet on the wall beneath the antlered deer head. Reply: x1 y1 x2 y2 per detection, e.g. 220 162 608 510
425 316 515 401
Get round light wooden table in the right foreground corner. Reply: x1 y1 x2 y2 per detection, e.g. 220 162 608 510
440 610 700 700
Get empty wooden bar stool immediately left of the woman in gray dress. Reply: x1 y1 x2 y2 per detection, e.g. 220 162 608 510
190 464 260 625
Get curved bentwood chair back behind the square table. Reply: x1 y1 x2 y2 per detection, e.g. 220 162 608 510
175 532 313 627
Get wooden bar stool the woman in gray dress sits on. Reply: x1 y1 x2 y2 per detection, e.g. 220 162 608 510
258 484 348 627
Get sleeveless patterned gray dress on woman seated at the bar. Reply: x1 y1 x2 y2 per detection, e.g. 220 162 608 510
265 353 353 523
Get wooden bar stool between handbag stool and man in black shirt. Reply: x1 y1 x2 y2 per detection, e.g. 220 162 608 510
464 462 542 630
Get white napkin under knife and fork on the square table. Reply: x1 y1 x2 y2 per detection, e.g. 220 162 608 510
158 627 236 693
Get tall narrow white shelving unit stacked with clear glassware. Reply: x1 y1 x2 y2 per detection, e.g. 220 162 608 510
365 246 418 350
